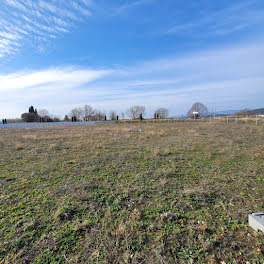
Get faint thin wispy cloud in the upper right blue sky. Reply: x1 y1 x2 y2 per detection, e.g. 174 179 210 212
167 1 264 36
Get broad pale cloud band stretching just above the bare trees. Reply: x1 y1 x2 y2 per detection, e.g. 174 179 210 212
0 41 264 117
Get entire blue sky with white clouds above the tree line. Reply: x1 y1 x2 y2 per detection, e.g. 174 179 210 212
0 0 264 118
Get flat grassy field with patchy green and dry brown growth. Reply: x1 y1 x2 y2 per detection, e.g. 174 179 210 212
0 122 264 264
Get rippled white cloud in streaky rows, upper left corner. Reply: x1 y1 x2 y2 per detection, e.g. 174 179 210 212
0 0 93 57
